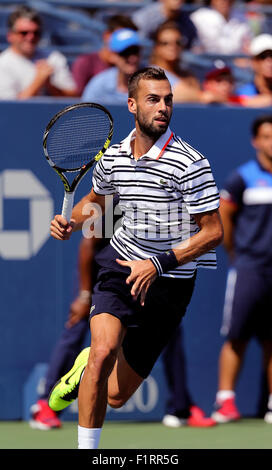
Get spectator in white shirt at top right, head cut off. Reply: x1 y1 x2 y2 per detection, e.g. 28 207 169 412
191 0 253 54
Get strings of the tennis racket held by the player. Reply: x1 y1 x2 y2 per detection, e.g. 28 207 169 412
47 110 110 170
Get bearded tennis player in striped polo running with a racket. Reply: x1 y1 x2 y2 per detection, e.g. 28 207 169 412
49 67 223 449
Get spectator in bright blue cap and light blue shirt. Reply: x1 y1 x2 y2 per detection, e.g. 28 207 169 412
82 28 141 104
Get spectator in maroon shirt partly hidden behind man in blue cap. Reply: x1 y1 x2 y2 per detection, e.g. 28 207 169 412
72 15 138 96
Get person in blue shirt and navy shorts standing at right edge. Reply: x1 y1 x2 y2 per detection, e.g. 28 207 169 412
212 115 272 423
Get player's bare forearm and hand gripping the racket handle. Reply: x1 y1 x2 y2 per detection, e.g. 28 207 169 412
50 189 105 240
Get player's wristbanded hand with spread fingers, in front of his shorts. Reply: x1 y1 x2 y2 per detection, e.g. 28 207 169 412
116 259 157 306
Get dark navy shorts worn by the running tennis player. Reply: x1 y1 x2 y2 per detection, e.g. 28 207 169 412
90 246 195 378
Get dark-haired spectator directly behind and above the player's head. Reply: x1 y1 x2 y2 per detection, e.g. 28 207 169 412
150 21 200 102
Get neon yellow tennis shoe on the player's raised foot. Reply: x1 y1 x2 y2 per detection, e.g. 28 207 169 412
48 348 90 411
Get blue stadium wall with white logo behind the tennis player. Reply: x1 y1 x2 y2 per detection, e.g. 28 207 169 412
0 100 272 420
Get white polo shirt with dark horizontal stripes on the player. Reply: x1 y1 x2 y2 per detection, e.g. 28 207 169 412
93 128 219 278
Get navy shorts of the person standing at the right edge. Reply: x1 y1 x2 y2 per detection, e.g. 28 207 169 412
221 266 272 341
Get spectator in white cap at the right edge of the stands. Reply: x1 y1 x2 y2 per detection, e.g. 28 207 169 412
237 34 272 107
